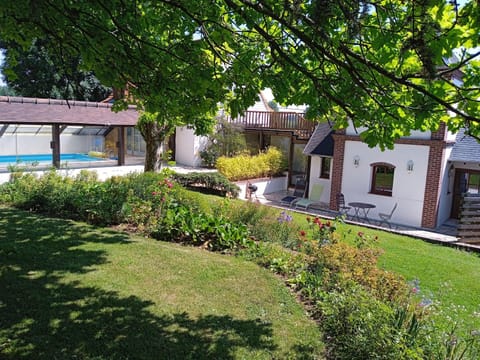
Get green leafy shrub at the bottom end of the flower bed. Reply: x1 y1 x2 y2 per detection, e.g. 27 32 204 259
318 282 423 360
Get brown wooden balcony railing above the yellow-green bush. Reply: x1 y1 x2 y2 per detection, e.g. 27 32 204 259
228 111 315 139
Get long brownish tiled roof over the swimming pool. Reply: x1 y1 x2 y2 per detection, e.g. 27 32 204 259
0 96 139 126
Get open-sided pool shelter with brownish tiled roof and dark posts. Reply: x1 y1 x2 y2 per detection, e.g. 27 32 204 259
0 96 138 167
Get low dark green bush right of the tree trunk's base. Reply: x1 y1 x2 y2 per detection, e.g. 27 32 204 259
173 172 240 198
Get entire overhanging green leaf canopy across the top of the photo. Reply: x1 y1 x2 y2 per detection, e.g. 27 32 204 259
0 0 480 147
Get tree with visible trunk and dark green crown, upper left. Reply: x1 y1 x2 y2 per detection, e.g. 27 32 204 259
0 0 259 171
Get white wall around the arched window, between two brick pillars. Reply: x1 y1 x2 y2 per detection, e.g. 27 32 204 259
342 141 429 226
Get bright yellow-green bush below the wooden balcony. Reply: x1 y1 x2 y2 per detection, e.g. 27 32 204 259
216 147 285 181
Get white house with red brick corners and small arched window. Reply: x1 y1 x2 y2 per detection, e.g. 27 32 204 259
304 124 480 228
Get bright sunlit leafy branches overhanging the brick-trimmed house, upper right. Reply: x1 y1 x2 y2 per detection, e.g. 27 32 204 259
219 0 480 147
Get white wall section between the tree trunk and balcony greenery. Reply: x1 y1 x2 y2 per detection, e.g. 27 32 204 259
175 126 208 167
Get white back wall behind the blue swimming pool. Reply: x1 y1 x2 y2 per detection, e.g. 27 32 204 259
0 134 104 155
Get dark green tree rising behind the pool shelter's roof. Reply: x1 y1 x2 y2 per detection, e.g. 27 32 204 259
0 39 112 101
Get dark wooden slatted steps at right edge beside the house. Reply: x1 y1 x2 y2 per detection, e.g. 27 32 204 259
458 193 480 244
